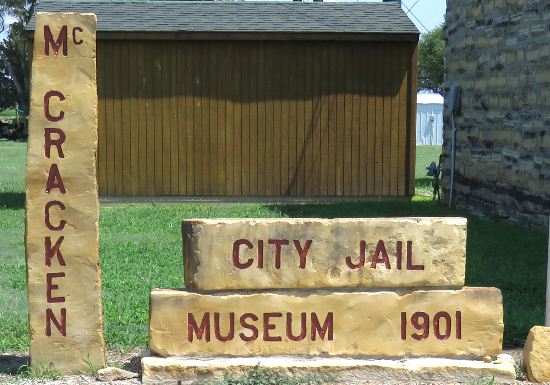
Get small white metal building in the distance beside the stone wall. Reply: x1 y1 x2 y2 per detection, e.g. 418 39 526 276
416 92 443 146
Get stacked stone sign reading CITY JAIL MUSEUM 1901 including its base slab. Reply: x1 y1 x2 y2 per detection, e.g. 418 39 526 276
142 214 515 385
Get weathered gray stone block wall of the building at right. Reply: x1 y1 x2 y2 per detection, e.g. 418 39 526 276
442 0 550 224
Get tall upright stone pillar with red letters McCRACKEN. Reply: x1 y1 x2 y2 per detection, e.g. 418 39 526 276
26 12 105 373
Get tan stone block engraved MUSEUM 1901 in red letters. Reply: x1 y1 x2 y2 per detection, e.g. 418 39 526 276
149 288 503 357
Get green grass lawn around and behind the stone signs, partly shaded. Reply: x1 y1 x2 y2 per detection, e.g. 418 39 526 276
0 141 547 352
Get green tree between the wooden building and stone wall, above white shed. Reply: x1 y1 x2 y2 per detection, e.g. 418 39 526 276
418 25 445 94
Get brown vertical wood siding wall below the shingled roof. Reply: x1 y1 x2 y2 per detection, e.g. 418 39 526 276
97 40 416 197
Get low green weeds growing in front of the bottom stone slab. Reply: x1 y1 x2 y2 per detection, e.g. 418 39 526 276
205 365 336 385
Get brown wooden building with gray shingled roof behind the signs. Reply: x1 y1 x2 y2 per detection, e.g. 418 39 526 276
28 0 419 197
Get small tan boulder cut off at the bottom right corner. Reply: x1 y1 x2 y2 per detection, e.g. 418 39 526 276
523 326 550 382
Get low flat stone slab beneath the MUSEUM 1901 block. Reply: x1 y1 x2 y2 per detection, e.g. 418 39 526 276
141 354 516 385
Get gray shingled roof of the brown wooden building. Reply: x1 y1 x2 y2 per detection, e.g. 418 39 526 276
27 0 419 34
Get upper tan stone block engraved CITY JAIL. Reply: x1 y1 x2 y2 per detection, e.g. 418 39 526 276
182 218 466 290
